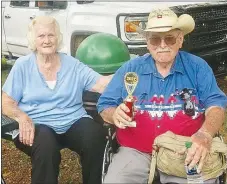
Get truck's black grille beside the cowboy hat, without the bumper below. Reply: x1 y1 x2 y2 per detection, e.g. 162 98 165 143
174 4 227 51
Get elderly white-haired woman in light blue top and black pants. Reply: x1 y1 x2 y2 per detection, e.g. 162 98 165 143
2 16 111 184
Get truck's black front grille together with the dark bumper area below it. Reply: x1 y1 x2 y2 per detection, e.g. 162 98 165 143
173 3 227 76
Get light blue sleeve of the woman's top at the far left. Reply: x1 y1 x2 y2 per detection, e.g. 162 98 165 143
2 59 24 102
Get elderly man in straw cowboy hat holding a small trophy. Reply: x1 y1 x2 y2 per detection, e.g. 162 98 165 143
97 9 227 183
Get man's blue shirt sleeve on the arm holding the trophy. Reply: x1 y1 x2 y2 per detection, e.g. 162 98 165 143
97 64 126 113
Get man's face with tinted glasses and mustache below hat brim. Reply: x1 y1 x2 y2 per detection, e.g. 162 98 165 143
146 30 184 64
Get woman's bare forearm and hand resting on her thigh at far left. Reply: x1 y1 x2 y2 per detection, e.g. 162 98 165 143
2 92 35 146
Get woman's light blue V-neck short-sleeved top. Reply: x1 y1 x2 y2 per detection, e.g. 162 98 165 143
2 53 100 134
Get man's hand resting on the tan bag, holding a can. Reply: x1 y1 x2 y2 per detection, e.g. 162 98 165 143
185 130 212 173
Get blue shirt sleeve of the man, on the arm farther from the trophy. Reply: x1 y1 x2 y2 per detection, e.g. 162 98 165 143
197 63 227 109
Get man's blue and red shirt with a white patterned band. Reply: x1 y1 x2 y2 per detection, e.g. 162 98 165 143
97 51 227 153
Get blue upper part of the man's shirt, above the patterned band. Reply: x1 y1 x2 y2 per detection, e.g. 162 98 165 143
97 51 227 112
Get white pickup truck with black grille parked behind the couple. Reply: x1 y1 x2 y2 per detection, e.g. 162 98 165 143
2 0 227 75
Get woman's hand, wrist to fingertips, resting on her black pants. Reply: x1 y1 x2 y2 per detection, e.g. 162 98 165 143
19 115 35 146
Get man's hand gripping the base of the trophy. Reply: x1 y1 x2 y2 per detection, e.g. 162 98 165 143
113 103 132 129
